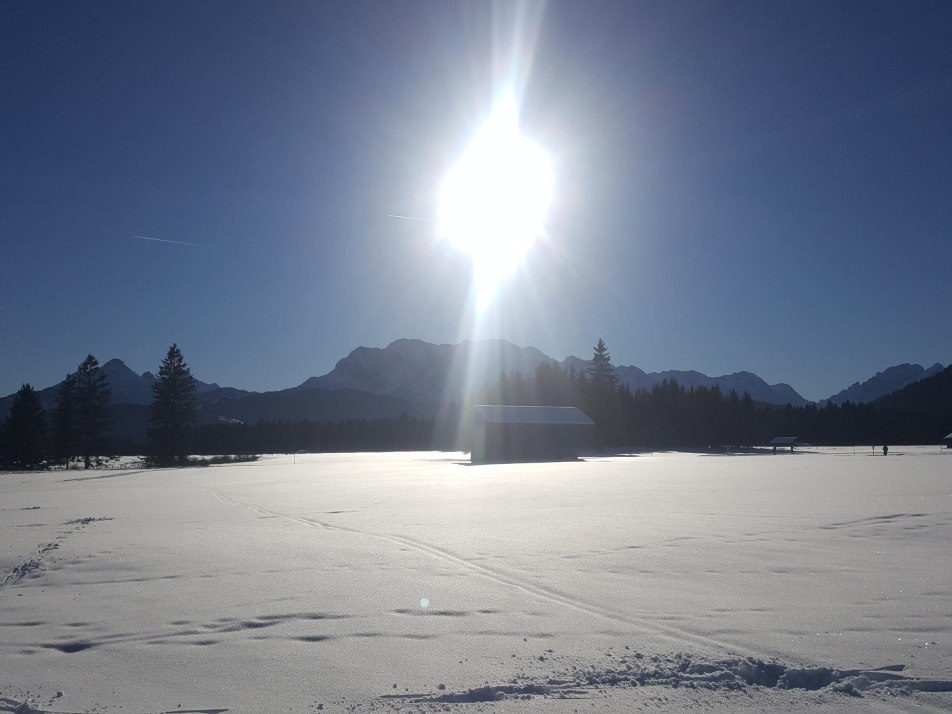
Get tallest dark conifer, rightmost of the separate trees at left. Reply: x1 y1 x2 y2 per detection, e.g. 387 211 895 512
149 344 196 465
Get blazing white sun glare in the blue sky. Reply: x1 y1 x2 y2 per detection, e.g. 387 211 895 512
437 97 554 307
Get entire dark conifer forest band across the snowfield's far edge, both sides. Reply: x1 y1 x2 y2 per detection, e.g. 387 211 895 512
0 340 952 469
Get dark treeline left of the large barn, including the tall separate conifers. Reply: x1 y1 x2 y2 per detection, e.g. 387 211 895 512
0 344 450 469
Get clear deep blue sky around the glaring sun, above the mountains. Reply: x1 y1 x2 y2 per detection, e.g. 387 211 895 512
0 0 952 399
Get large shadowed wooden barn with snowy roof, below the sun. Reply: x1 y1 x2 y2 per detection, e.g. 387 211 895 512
471 404 595 464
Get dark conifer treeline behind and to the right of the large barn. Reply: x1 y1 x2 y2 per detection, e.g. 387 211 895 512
482 340 952 449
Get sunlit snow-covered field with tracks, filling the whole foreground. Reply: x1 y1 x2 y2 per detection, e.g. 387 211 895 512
0 447 952 714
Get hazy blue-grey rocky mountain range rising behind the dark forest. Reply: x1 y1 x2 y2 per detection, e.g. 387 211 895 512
0 339 943 438
